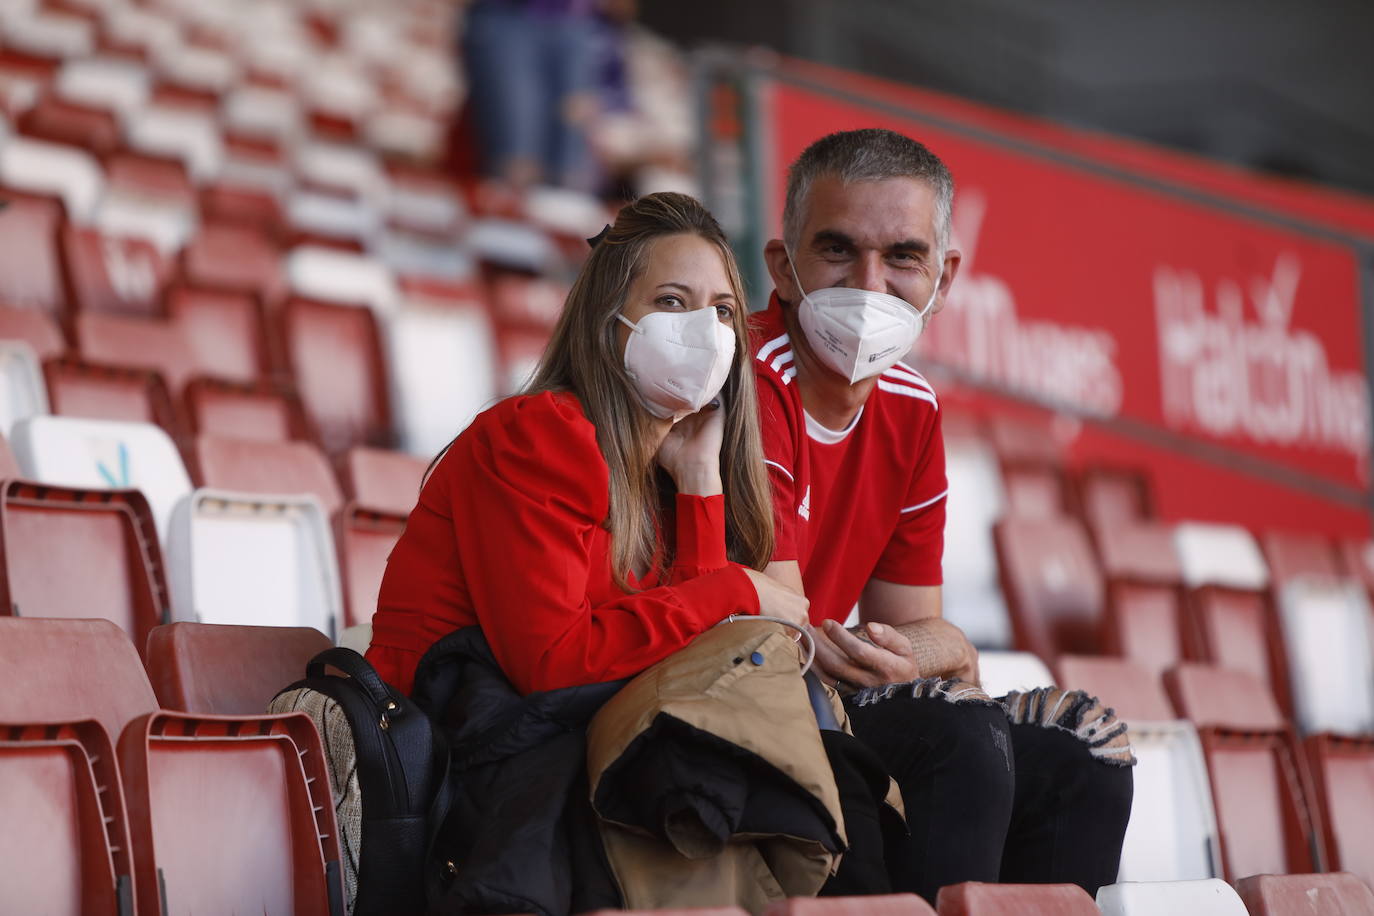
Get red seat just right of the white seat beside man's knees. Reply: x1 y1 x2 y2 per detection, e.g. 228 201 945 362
1165 663 1319 882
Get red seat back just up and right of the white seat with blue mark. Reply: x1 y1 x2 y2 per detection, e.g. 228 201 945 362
184 379 315 442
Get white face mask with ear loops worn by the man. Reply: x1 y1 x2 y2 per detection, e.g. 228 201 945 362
787 253 943 385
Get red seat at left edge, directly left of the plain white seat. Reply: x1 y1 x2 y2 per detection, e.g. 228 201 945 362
0 481 169 656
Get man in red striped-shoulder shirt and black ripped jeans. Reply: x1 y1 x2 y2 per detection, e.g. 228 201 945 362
752 129 1134 902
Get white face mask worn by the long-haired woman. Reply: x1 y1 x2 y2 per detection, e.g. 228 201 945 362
616 309 735 423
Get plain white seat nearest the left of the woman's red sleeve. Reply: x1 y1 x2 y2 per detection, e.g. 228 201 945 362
168 489 344 639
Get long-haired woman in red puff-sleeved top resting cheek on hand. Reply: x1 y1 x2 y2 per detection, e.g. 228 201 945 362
367 194 807 694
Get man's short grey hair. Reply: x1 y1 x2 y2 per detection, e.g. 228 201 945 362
782 128 954 254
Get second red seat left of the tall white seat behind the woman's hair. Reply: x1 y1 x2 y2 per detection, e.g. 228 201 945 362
166 286 271 383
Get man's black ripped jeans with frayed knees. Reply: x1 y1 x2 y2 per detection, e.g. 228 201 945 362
822 695 1134 905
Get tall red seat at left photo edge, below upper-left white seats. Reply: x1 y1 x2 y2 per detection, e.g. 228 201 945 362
0 188 67 316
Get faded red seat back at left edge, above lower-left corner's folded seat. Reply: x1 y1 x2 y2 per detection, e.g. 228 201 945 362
0 617 158 742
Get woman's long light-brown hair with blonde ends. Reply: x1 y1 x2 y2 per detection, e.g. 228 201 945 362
526 192 774 591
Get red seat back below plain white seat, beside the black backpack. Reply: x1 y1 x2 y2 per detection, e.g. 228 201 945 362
147 622 331 715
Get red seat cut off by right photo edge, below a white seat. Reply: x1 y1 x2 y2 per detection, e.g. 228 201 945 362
1304 735 1374 887
